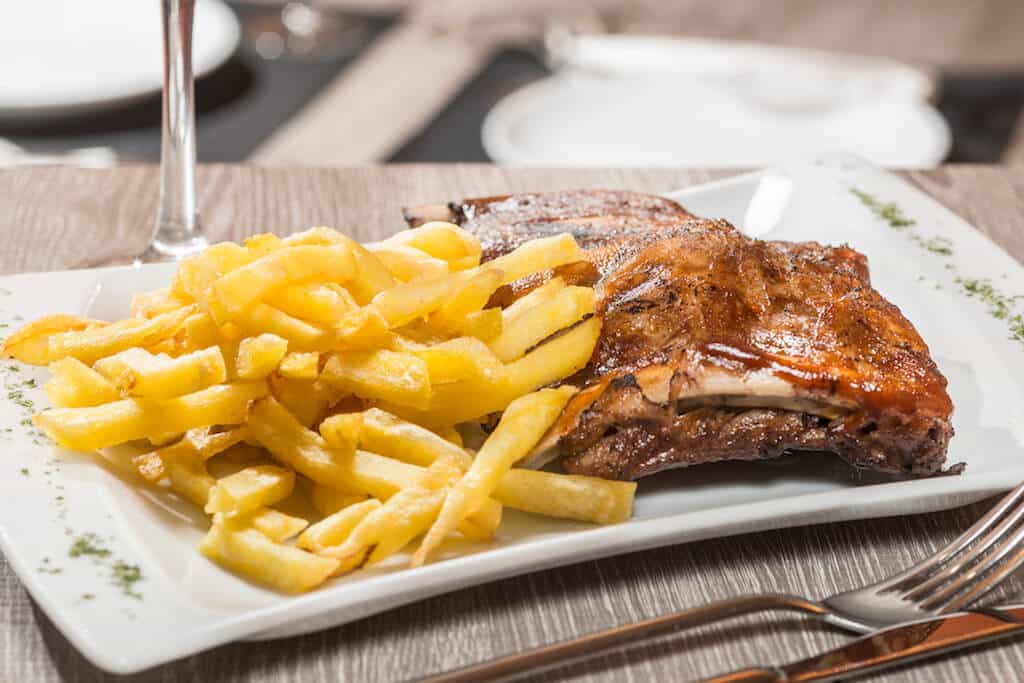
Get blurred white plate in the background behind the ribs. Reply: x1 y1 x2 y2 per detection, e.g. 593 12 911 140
482 36 951 168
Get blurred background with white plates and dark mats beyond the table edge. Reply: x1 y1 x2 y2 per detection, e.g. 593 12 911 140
0 0 1024 168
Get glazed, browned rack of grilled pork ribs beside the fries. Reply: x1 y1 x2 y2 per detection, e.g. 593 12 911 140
399 191 952 479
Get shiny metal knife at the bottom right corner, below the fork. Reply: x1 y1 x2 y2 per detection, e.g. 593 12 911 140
705 605 1024 683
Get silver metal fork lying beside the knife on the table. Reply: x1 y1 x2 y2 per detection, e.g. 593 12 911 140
424 483 1024 683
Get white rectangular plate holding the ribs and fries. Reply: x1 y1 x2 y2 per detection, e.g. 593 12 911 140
0 158 1024 673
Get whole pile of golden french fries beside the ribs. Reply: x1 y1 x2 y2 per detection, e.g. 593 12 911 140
2 222 635 593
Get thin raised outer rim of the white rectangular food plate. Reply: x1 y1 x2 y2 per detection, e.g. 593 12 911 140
0 156 1024 674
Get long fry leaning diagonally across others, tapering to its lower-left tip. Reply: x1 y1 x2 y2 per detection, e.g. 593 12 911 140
413 387 575 566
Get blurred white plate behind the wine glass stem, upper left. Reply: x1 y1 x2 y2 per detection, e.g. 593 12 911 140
0 0 241 119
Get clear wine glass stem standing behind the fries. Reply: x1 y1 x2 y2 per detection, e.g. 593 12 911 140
150 0 206 258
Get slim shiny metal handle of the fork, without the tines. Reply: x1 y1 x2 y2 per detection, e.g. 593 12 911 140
424 594 827 683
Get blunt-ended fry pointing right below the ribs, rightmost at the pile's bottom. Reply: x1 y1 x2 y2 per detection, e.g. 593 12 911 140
495 468 637 524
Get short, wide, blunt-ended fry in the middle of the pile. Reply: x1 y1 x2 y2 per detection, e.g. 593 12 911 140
321 349 431 409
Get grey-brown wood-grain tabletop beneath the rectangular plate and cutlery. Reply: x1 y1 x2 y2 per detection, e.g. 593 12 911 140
0 166 1024 683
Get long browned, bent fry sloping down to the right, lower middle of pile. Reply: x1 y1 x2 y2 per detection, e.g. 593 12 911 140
247 396 423 499
